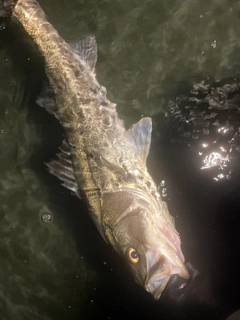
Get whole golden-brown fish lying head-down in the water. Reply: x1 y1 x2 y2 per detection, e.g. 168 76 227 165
0 0 189 299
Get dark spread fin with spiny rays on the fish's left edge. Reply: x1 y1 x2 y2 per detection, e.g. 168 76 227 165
47 140 80 198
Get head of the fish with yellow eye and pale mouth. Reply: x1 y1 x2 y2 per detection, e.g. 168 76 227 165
102 190 189 300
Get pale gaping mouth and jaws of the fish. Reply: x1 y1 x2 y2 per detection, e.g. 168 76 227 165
144 249 189 300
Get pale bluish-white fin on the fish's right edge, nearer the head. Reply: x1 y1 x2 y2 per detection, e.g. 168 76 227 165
127 118 152 164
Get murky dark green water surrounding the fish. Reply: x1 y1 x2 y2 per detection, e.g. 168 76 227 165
0 0 240 320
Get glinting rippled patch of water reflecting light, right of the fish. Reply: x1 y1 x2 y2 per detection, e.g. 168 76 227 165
166 80 240 181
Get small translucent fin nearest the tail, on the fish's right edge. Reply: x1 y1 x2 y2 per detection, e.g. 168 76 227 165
70 35 97 73
